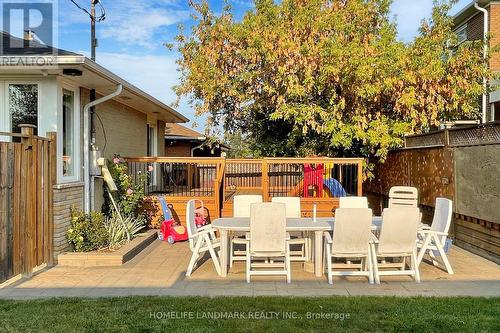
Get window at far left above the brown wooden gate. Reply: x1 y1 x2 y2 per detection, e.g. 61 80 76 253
8 84 38 134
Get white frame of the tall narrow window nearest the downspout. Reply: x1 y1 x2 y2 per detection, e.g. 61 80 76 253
57 82 82 184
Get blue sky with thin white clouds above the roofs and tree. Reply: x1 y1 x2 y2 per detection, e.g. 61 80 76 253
54 0 471 131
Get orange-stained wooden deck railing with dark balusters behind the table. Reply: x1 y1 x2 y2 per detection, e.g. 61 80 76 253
125 157 363 227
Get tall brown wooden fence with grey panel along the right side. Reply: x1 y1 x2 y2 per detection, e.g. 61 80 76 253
365 123 500 263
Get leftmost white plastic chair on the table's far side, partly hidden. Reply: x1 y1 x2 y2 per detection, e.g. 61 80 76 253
229 195 262 267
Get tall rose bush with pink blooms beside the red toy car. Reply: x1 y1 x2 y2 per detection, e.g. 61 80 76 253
106 155 149 216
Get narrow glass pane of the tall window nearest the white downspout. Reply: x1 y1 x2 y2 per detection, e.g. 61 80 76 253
62 89 75 177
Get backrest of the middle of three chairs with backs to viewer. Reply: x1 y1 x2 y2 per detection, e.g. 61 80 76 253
332 208 372 254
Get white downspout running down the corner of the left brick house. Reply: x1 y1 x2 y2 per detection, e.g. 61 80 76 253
83 84 123 213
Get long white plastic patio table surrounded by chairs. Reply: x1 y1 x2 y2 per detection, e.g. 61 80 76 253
212 216 382 277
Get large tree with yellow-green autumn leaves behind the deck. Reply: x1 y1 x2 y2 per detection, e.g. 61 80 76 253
175 0 491 170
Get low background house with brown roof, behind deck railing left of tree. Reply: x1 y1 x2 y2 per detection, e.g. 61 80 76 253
165 123 229 157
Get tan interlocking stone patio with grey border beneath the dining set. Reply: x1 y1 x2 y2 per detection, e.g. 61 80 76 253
0 241 500 299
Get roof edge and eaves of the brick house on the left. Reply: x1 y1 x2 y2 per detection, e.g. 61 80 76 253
0 32 189 123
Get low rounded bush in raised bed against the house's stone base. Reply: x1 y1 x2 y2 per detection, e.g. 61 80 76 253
66 209 108 252
